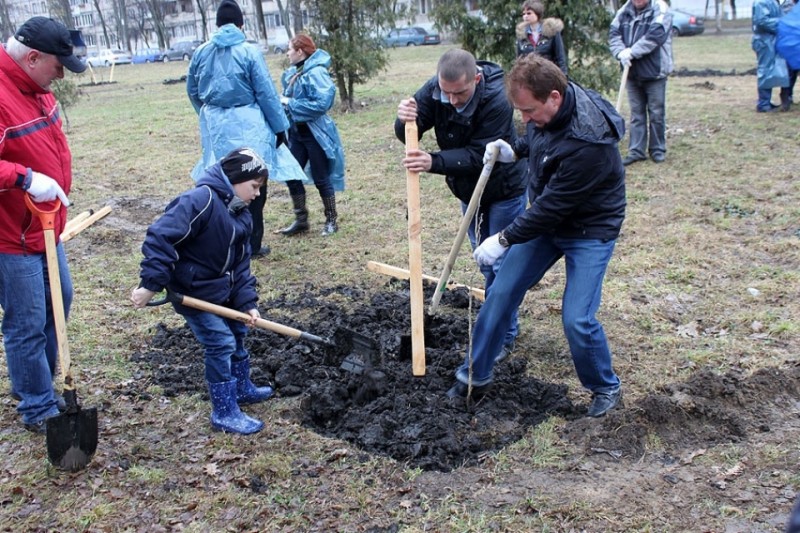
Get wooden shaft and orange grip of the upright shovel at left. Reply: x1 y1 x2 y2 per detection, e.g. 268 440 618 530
25 194 75 393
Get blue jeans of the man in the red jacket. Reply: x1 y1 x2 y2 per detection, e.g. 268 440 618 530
0 244 72 424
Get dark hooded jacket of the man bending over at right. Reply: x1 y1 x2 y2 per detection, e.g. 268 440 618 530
504 82 625 244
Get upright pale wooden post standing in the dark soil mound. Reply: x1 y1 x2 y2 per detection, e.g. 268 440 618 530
406 120 425 376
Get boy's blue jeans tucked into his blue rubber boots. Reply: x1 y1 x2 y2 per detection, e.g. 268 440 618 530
183 313 248 383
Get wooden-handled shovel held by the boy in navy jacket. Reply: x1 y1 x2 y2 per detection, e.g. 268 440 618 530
147 291 380 374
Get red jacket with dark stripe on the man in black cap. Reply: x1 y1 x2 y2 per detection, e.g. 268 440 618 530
0 47 72 254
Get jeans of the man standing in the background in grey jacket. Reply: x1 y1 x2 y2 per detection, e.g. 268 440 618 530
626 78 667 158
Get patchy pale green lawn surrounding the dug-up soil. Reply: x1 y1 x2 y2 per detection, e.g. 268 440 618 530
0 33 800 532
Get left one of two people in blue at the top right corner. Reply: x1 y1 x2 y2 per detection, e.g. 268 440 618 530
751 0 789 113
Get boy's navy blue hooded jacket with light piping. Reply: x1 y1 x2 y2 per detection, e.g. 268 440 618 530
140 163 258 315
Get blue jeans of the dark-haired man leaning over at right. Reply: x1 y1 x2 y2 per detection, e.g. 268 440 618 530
456 236 620 393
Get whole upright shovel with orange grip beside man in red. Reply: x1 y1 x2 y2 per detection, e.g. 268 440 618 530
25 194 98 472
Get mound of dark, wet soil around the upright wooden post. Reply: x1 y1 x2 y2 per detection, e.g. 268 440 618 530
133 281 580 471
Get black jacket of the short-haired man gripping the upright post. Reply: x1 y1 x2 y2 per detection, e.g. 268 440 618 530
394 61 525 205
